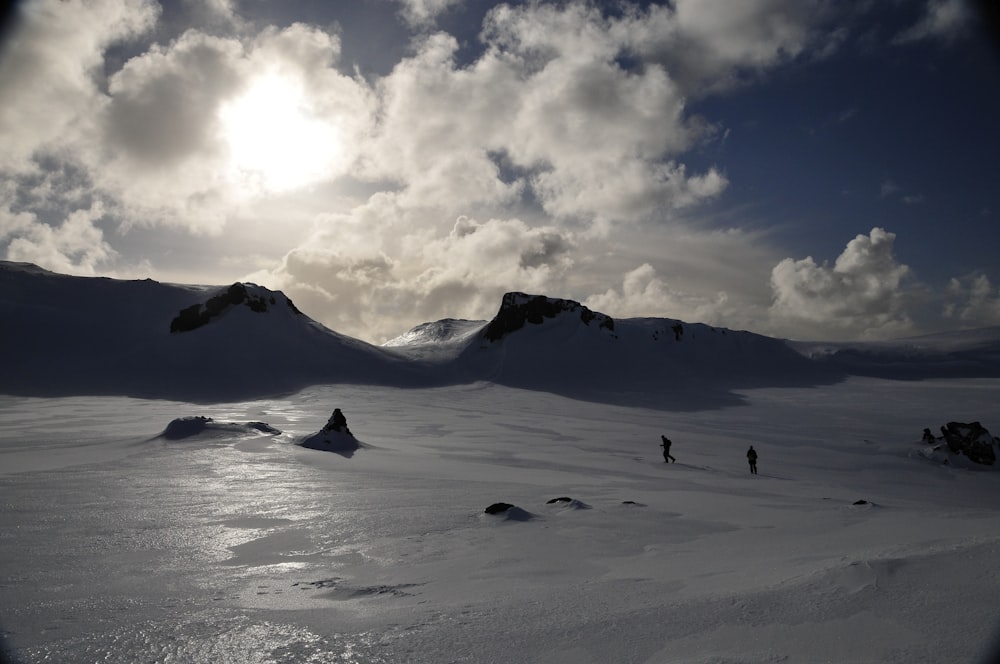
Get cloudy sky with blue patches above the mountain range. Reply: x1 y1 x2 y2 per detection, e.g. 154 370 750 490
0 0 1000 343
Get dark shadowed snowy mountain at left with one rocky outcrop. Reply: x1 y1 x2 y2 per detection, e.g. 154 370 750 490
0 263 425 400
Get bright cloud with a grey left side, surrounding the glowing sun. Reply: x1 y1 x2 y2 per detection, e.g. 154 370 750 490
90 24 373 232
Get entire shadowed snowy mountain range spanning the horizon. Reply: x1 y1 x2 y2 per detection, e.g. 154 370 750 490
0 261 1000 409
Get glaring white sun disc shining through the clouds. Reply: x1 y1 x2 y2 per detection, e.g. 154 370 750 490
219 74 342 192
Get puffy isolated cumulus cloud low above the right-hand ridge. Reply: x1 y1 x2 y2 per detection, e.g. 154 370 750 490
770 228 914 340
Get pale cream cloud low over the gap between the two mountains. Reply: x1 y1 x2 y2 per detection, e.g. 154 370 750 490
248 194 574 342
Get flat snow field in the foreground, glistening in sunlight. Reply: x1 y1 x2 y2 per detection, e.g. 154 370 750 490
0 379 1000 664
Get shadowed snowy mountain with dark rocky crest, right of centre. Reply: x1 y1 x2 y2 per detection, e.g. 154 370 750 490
410 293 842 406
